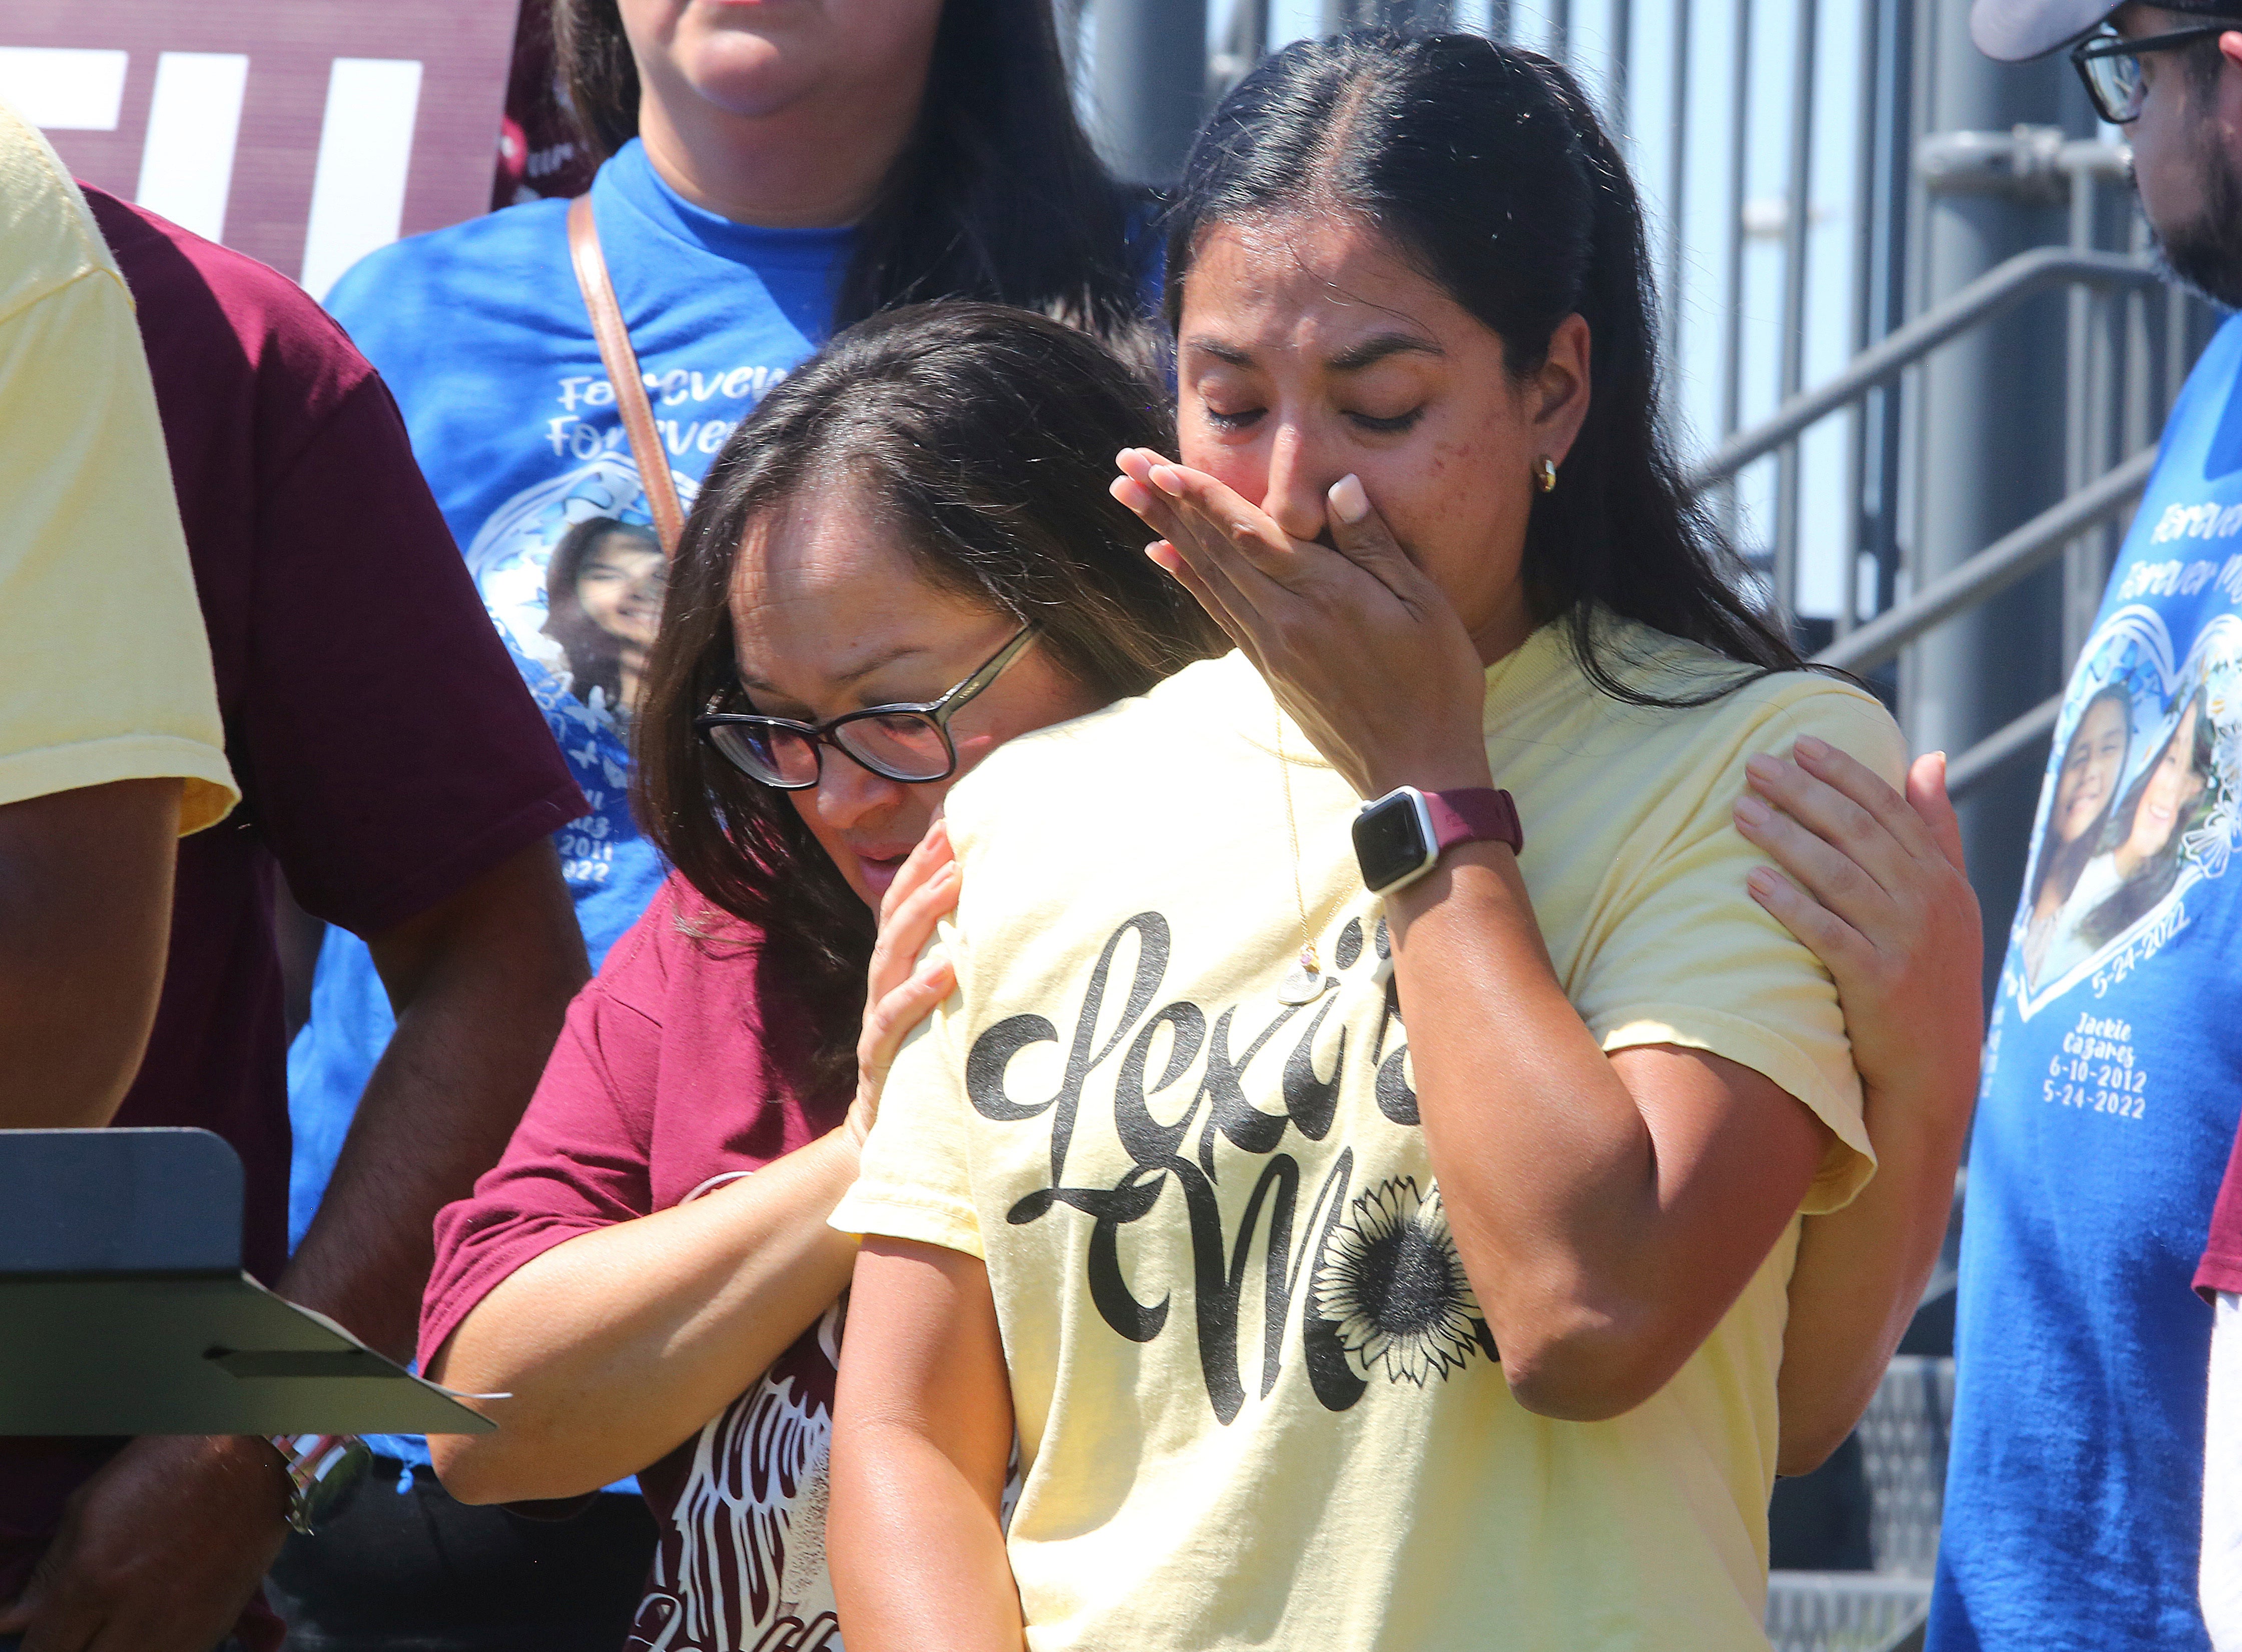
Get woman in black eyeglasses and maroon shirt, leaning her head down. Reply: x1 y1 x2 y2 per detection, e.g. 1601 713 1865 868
421 305 1220 1652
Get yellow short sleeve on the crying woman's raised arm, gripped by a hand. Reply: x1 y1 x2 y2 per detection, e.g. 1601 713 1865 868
1571 679 1906 1215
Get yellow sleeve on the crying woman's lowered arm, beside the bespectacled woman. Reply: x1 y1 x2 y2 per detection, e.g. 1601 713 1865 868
830 926 986 1258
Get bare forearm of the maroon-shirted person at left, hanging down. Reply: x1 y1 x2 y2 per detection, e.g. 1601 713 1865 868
280 843 588 1358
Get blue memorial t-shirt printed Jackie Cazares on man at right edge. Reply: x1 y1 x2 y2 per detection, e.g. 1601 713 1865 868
1930 318 2242 1652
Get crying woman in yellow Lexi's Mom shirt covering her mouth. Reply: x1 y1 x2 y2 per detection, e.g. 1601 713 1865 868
830 34 1966 1652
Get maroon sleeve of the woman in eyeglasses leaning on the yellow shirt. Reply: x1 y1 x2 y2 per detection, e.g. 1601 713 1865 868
419 888 675 1365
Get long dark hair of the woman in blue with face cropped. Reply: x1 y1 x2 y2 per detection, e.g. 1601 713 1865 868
554 0 1150 343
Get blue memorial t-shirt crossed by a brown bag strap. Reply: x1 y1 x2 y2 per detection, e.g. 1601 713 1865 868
289 141 850 1461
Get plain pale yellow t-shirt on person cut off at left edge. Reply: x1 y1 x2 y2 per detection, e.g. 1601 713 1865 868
0 103 238 834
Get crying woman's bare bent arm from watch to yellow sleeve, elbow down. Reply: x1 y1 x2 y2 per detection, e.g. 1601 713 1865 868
1388 845 1821 1421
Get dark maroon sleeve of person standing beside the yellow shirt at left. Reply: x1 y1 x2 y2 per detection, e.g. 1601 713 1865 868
243 370 585 935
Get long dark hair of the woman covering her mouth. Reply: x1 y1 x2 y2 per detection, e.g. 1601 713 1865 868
1166 29 1805 706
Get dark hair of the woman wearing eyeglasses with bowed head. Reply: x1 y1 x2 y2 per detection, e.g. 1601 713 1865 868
632 303 1227 1078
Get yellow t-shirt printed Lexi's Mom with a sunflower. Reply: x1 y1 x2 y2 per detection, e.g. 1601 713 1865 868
834 621 1901 1652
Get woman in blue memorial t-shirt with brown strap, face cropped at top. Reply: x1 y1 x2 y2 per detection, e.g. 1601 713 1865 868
276 0 1153 1652
